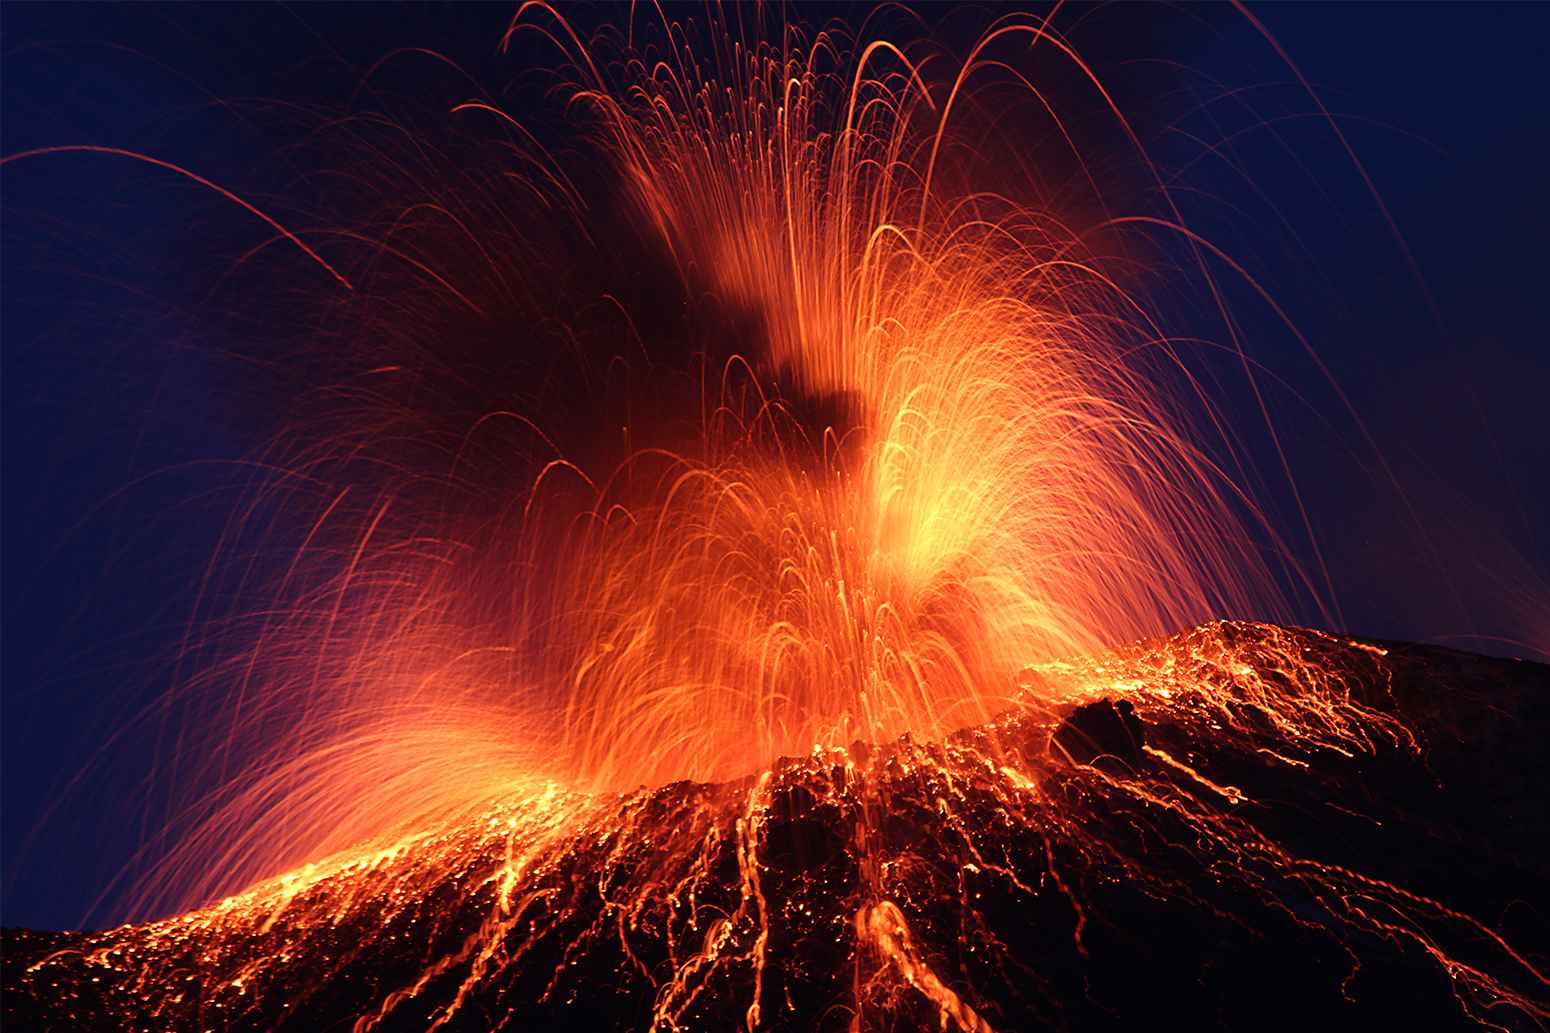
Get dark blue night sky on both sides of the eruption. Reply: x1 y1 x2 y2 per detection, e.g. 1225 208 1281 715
0 3 1550 929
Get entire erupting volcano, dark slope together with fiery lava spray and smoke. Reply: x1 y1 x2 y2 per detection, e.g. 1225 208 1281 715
5 3 1550 1033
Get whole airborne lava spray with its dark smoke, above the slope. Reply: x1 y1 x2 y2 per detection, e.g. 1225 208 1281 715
99 5 1295 912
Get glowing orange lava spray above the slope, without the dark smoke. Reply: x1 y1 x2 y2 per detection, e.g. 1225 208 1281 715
124 8 1295 897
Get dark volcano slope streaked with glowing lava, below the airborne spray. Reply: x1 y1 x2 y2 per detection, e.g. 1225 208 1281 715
5 622 1550 1033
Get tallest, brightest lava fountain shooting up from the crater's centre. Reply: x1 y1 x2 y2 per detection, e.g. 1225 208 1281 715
544 10 1289 785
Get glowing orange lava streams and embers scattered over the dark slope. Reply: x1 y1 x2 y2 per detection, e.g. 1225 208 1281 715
27 622 1550 1033
